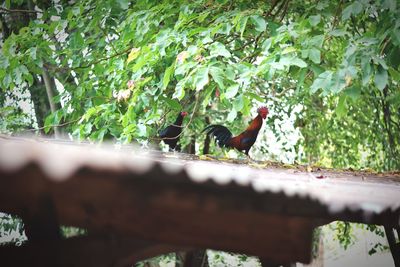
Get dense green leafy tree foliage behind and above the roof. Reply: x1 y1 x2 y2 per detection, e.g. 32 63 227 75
0 0 400 170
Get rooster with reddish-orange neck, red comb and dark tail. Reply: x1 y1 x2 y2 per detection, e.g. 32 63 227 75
203 106 269 158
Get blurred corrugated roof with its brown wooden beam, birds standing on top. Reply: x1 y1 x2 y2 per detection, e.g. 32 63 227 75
0 137 400 262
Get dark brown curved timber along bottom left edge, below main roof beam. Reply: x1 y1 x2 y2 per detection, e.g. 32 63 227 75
0 236 190 267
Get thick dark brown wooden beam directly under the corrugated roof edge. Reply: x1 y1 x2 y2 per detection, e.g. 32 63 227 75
0 165 315 262
